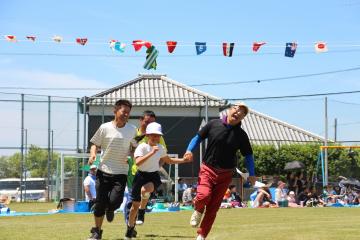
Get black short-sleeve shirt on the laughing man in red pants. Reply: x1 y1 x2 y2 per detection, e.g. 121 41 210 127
198 119 253 169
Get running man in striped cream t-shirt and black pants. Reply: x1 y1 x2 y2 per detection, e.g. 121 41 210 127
88 100 136 240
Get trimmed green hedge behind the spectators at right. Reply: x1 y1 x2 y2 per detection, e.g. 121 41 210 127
239 144 360 181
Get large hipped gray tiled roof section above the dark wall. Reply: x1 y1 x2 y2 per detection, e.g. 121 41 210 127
89 74 226 107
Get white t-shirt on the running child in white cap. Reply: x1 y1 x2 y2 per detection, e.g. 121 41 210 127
134 143 166 172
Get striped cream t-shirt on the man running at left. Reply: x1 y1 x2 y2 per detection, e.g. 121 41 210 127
90 122 136 175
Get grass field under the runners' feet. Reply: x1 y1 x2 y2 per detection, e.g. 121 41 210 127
0 203 360 240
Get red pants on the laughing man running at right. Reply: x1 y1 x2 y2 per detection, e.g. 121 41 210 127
194 164 233 237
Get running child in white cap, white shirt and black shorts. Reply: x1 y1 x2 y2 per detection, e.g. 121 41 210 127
125 122 189 239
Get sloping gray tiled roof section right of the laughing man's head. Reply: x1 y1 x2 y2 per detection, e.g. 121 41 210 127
242 109 324 144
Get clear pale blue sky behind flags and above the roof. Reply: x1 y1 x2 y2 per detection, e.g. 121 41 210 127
0 0 360 155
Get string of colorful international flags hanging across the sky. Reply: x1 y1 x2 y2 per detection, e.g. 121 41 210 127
4 35 338 70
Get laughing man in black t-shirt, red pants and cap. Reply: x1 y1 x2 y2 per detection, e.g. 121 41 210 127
184 103 256 240
